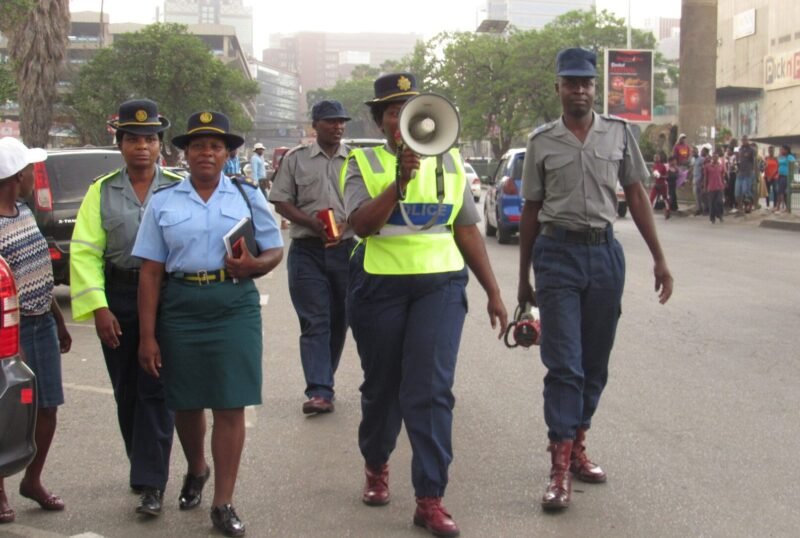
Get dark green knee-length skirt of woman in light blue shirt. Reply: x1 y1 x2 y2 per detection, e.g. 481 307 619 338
157 278 262 410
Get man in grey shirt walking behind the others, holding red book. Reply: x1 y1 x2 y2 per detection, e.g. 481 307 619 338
269 100 353 414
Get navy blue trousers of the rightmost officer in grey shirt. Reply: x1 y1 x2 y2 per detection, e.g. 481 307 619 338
533 229 625 441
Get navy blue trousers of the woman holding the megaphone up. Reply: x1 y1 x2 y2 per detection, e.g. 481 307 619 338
348 247 468 497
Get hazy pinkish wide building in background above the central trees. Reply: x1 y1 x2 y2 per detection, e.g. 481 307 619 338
262 32 423 116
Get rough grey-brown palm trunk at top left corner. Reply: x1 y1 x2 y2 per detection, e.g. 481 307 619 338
0 0 70 147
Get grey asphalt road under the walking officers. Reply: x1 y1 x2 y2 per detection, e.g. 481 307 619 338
0 202 800 538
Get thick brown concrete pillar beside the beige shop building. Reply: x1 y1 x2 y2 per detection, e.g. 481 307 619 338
678 0 717 146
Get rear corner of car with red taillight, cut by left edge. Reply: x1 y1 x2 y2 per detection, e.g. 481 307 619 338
0 253 36 476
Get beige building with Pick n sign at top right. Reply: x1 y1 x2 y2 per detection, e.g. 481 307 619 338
716 0 800 148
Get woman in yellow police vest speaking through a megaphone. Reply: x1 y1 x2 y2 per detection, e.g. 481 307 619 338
342 73 506 536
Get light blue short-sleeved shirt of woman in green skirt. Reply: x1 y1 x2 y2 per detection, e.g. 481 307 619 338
133 174 283 273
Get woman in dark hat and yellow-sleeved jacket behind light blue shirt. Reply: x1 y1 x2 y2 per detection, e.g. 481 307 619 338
70 99 181 516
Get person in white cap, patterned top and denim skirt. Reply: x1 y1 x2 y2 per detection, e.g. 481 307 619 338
0 137 72 523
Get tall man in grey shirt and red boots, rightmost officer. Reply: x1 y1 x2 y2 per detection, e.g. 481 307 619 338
517 48 672 510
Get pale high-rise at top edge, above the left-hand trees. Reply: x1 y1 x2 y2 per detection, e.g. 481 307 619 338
164 0 253 56
